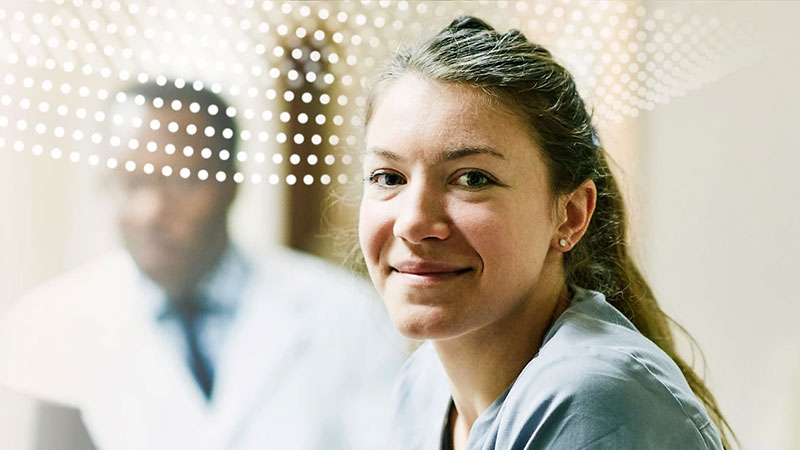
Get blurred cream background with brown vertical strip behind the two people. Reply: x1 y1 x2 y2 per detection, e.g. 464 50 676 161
0 0 800 449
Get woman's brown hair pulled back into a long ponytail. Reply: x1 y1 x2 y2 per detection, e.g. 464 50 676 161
366 16 738 448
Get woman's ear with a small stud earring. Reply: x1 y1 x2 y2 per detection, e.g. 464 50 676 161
552 179 597 252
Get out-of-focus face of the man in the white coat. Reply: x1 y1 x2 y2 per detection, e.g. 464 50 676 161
112 103 236 294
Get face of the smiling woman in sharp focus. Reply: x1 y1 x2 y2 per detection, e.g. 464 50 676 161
359 75 561 339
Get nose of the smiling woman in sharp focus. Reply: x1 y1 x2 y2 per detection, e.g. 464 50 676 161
393 185 451 244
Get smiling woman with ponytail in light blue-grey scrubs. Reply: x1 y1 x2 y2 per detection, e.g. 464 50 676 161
359 17 730 450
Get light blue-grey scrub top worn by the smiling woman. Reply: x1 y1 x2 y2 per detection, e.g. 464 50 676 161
394 289 722 450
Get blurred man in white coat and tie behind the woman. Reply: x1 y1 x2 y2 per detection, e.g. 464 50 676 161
0 83 404 449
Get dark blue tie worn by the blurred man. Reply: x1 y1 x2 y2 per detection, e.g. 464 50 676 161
176 299 214 400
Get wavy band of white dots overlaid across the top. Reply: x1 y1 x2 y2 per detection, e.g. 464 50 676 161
0 0 758 186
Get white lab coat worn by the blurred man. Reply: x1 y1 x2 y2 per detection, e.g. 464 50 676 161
0 250 406 450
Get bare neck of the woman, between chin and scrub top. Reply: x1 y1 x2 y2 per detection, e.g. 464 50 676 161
433 270 569 440
